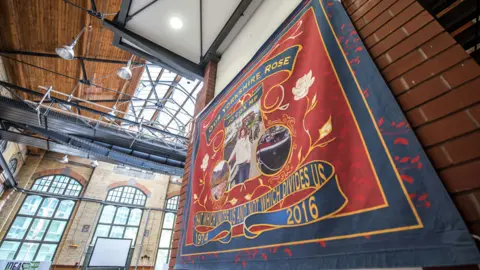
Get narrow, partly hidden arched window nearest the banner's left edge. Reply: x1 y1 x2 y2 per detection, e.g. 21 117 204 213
155 196 180 269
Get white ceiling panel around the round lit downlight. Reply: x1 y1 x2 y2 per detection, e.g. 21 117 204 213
125 0 201 63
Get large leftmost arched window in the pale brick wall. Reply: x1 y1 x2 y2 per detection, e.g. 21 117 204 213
0 175 82 261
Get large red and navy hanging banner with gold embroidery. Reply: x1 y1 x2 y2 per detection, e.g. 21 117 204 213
176 0 480 269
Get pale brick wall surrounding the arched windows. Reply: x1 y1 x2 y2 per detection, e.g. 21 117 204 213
0 152 181 269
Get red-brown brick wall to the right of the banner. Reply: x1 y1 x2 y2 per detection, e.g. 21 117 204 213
342 0 480 270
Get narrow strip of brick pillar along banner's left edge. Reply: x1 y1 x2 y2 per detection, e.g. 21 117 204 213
169 62 217 269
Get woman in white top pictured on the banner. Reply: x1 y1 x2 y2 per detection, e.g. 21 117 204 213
228 126 252 184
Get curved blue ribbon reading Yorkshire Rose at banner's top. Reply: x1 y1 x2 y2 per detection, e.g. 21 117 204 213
206 45 301 141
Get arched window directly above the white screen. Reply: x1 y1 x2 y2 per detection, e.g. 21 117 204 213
92 186 147 246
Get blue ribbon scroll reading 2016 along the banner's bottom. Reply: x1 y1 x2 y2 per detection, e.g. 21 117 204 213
193 161 348 246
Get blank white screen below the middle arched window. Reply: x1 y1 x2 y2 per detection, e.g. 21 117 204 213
88 237 132 267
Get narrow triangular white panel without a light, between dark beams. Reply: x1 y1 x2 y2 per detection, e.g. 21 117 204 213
202 0 241 55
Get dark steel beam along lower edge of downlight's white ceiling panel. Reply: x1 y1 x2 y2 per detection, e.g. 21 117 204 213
103 20 204 79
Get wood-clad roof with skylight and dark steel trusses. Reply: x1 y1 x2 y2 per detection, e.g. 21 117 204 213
0 0 207 176
